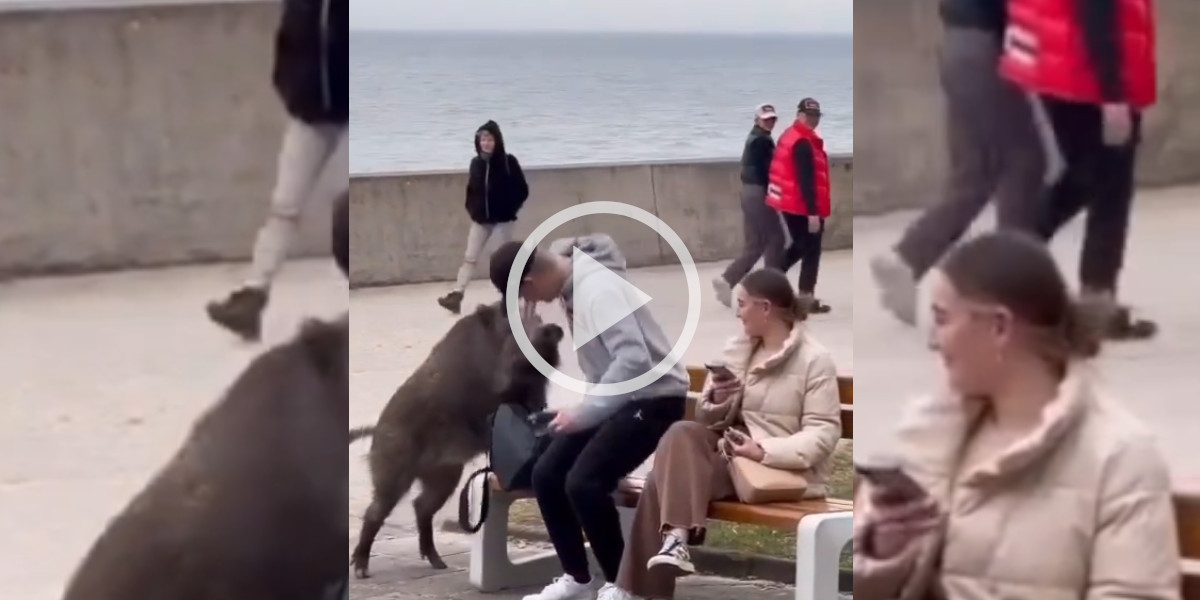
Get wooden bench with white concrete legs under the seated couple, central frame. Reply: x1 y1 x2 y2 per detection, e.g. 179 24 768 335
469 367 854 600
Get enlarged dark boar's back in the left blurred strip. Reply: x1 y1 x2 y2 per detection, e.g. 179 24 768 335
64 317 349 600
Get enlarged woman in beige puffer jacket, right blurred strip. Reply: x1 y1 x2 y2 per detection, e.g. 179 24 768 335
854 233 1182 600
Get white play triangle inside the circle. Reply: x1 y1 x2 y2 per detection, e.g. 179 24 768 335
571 248 653 350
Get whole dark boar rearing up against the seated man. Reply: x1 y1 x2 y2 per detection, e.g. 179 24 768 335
350 304 563 577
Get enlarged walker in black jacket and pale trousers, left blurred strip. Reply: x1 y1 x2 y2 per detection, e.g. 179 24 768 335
208 0 350 341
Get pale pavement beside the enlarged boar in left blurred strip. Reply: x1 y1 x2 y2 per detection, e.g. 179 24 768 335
0 259 347 600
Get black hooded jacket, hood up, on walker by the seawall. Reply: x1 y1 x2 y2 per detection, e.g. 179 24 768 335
467 121 529 224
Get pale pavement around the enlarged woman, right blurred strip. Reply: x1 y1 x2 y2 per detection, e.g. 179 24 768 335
853 187 1200 490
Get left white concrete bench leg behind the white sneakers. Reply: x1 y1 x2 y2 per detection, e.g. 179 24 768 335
469 492 563 592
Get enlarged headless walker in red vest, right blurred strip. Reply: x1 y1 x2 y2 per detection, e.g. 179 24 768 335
1001 0 1157 338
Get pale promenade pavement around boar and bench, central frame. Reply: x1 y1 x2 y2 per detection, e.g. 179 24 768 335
347 252 853 600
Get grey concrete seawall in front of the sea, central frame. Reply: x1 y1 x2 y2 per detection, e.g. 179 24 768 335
350 156 853 287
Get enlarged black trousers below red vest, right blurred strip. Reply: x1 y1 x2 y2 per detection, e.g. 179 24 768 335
1037 98 1141 293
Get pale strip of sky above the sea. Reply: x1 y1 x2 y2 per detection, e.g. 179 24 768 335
350 0 854 34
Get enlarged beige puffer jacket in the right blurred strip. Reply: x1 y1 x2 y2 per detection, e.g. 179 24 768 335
854 366 1182 600
